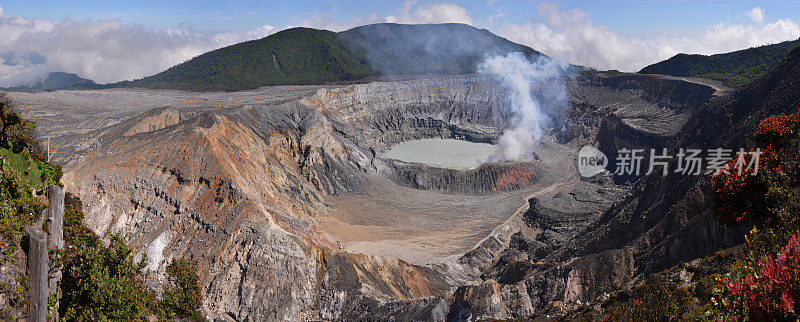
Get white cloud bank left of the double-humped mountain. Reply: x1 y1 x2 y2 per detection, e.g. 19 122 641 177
0 16 278 86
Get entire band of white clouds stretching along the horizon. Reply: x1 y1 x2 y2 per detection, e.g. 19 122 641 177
0 0 800 87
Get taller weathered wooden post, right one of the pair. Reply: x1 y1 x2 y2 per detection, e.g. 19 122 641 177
47 184 64 321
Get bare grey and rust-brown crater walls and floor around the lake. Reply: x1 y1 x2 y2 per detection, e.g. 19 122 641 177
11 63 764 320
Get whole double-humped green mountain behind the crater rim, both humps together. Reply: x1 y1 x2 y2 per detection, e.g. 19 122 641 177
123 24 552 91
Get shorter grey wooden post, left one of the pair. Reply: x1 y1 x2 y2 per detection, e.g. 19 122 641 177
26 225 49 322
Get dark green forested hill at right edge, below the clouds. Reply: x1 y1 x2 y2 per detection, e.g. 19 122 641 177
639 39 800 88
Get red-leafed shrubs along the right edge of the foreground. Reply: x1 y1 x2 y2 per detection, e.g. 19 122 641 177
711 111 800 320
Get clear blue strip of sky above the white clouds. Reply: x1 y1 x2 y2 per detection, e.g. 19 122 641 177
0 0 800 34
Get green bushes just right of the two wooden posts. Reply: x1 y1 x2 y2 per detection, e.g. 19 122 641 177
61 195 203 321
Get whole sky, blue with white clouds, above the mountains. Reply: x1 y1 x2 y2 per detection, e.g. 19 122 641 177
0 0 800 86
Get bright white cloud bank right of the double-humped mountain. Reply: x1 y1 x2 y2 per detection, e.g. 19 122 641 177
500 3 800 71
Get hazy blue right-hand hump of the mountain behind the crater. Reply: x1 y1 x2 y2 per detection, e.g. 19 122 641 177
339 23 541 75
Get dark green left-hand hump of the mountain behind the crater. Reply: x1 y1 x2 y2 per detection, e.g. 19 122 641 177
128 28 370 91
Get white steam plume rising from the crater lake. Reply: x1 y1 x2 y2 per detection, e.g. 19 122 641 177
478 53 568 161
